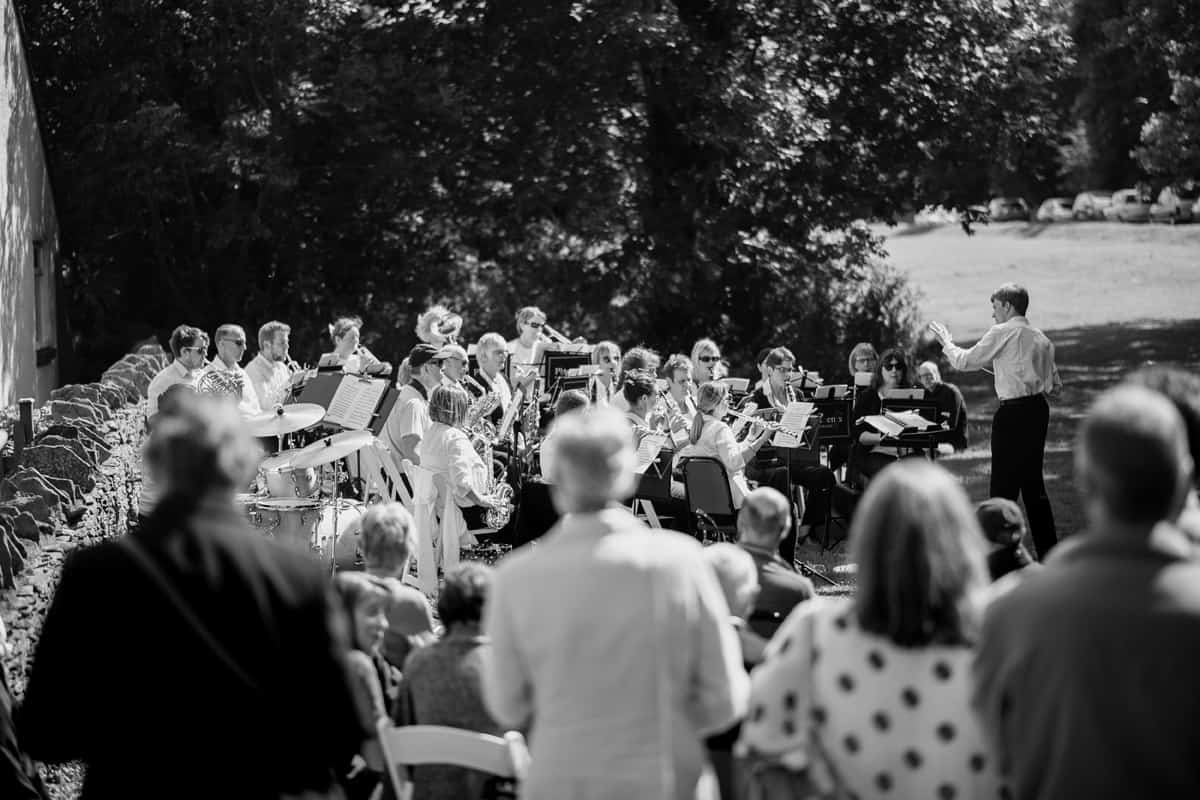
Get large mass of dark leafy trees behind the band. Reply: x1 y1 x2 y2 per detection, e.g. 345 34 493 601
18 0 1132 372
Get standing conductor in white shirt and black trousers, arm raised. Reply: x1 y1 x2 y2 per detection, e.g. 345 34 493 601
929 283 1062 559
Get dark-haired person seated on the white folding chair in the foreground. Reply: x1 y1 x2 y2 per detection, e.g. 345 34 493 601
395 561 504 800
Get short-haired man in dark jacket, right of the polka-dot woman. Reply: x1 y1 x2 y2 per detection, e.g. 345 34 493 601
974 385 1200 799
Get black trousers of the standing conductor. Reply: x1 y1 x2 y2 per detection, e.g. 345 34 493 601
990 395 1058 559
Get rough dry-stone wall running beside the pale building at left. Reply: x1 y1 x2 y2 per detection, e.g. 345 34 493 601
0 345 168 696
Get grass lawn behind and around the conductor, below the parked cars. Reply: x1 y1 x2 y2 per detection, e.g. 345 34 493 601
800 223 1200 587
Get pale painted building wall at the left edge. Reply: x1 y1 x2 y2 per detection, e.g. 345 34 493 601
0 0 60 407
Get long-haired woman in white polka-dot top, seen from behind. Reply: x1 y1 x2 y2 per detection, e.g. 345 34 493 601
742 459 1008 800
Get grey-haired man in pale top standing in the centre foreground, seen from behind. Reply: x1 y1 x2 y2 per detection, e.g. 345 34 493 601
484 409 748 800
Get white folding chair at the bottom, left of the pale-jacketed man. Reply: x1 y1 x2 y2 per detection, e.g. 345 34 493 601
378 720 529 800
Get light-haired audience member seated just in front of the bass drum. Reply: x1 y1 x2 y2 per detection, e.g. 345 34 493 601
361 503 434 669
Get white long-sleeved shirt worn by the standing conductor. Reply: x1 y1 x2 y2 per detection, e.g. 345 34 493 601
943 315 1062 401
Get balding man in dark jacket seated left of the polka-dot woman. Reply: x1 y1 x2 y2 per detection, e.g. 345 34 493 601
738 486 816 638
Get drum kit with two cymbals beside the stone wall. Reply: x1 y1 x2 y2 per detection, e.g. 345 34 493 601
238 403 376 570
